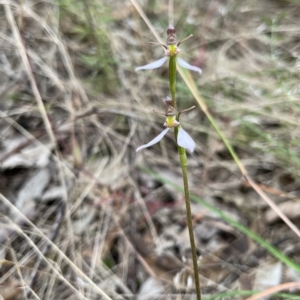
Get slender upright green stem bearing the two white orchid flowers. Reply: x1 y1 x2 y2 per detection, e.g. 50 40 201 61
169 56 201 300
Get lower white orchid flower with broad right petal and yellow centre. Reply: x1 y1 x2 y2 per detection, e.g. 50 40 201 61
136 107 195 152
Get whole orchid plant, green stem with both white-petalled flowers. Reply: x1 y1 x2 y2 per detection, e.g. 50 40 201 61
135 25 202 300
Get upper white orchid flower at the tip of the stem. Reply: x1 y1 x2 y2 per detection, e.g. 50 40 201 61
135 25 202 74
